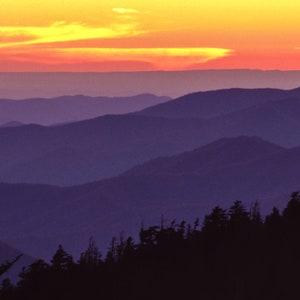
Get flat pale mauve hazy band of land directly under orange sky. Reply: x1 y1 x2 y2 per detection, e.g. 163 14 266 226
0 69 300 99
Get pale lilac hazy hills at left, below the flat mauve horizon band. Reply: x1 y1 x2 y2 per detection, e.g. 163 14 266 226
0 94 170 125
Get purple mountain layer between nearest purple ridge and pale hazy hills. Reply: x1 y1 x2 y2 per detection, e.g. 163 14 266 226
0 89 300 185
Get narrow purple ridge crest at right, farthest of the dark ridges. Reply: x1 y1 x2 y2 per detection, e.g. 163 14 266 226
138 88 300 119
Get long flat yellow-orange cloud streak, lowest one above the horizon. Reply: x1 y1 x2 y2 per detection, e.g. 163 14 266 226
0 46 234 71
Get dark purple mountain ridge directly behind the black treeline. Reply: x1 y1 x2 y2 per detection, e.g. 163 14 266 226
0 137 300 257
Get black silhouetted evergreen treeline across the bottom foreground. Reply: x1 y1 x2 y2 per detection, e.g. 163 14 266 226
0 192 300 300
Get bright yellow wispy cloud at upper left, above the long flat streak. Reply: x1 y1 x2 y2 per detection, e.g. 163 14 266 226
0 21 145 48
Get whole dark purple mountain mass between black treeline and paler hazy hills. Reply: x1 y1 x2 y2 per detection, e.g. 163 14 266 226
0 89 300 259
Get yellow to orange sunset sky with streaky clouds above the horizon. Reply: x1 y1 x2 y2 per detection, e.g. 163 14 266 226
0 0 300 72
